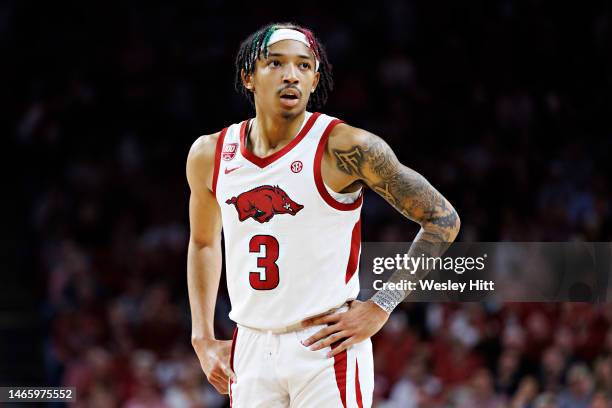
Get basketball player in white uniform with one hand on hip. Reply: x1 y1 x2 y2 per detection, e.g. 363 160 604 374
187 24 459 408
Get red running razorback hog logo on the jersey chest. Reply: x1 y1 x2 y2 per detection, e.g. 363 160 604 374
226 186 304 223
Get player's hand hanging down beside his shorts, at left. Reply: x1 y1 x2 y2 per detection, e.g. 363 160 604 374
191 339 236 394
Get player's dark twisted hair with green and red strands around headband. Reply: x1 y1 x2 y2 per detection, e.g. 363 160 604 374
234 23 334 109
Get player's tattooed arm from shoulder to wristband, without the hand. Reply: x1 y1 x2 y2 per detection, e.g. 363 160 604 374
324 124 460 313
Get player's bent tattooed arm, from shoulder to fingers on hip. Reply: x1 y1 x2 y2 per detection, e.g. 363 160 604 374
303 124 459 357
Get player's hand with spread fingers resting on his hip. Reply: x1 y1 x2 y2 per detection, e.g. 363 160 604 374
302 300 389 357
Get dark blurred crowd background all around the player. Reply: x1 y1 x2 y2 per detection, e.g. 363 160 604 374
5 0 612 408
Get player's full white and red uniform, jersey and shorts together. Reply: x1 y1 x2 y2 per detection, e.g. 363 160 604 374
213 112 373 408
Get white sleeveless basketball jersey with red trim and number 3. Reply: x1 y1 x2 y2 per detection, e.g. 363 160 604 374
213 112 363 329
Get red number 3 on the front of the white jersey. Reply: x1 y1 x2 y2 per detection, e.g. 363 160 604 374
249 235 279 290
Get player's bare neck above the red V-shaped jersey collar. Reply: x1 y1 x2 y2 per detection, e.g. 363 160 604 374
250 112 306 153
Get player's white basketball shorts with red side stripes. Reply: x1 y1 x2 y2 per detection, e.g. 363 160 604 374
230 314 374 408
